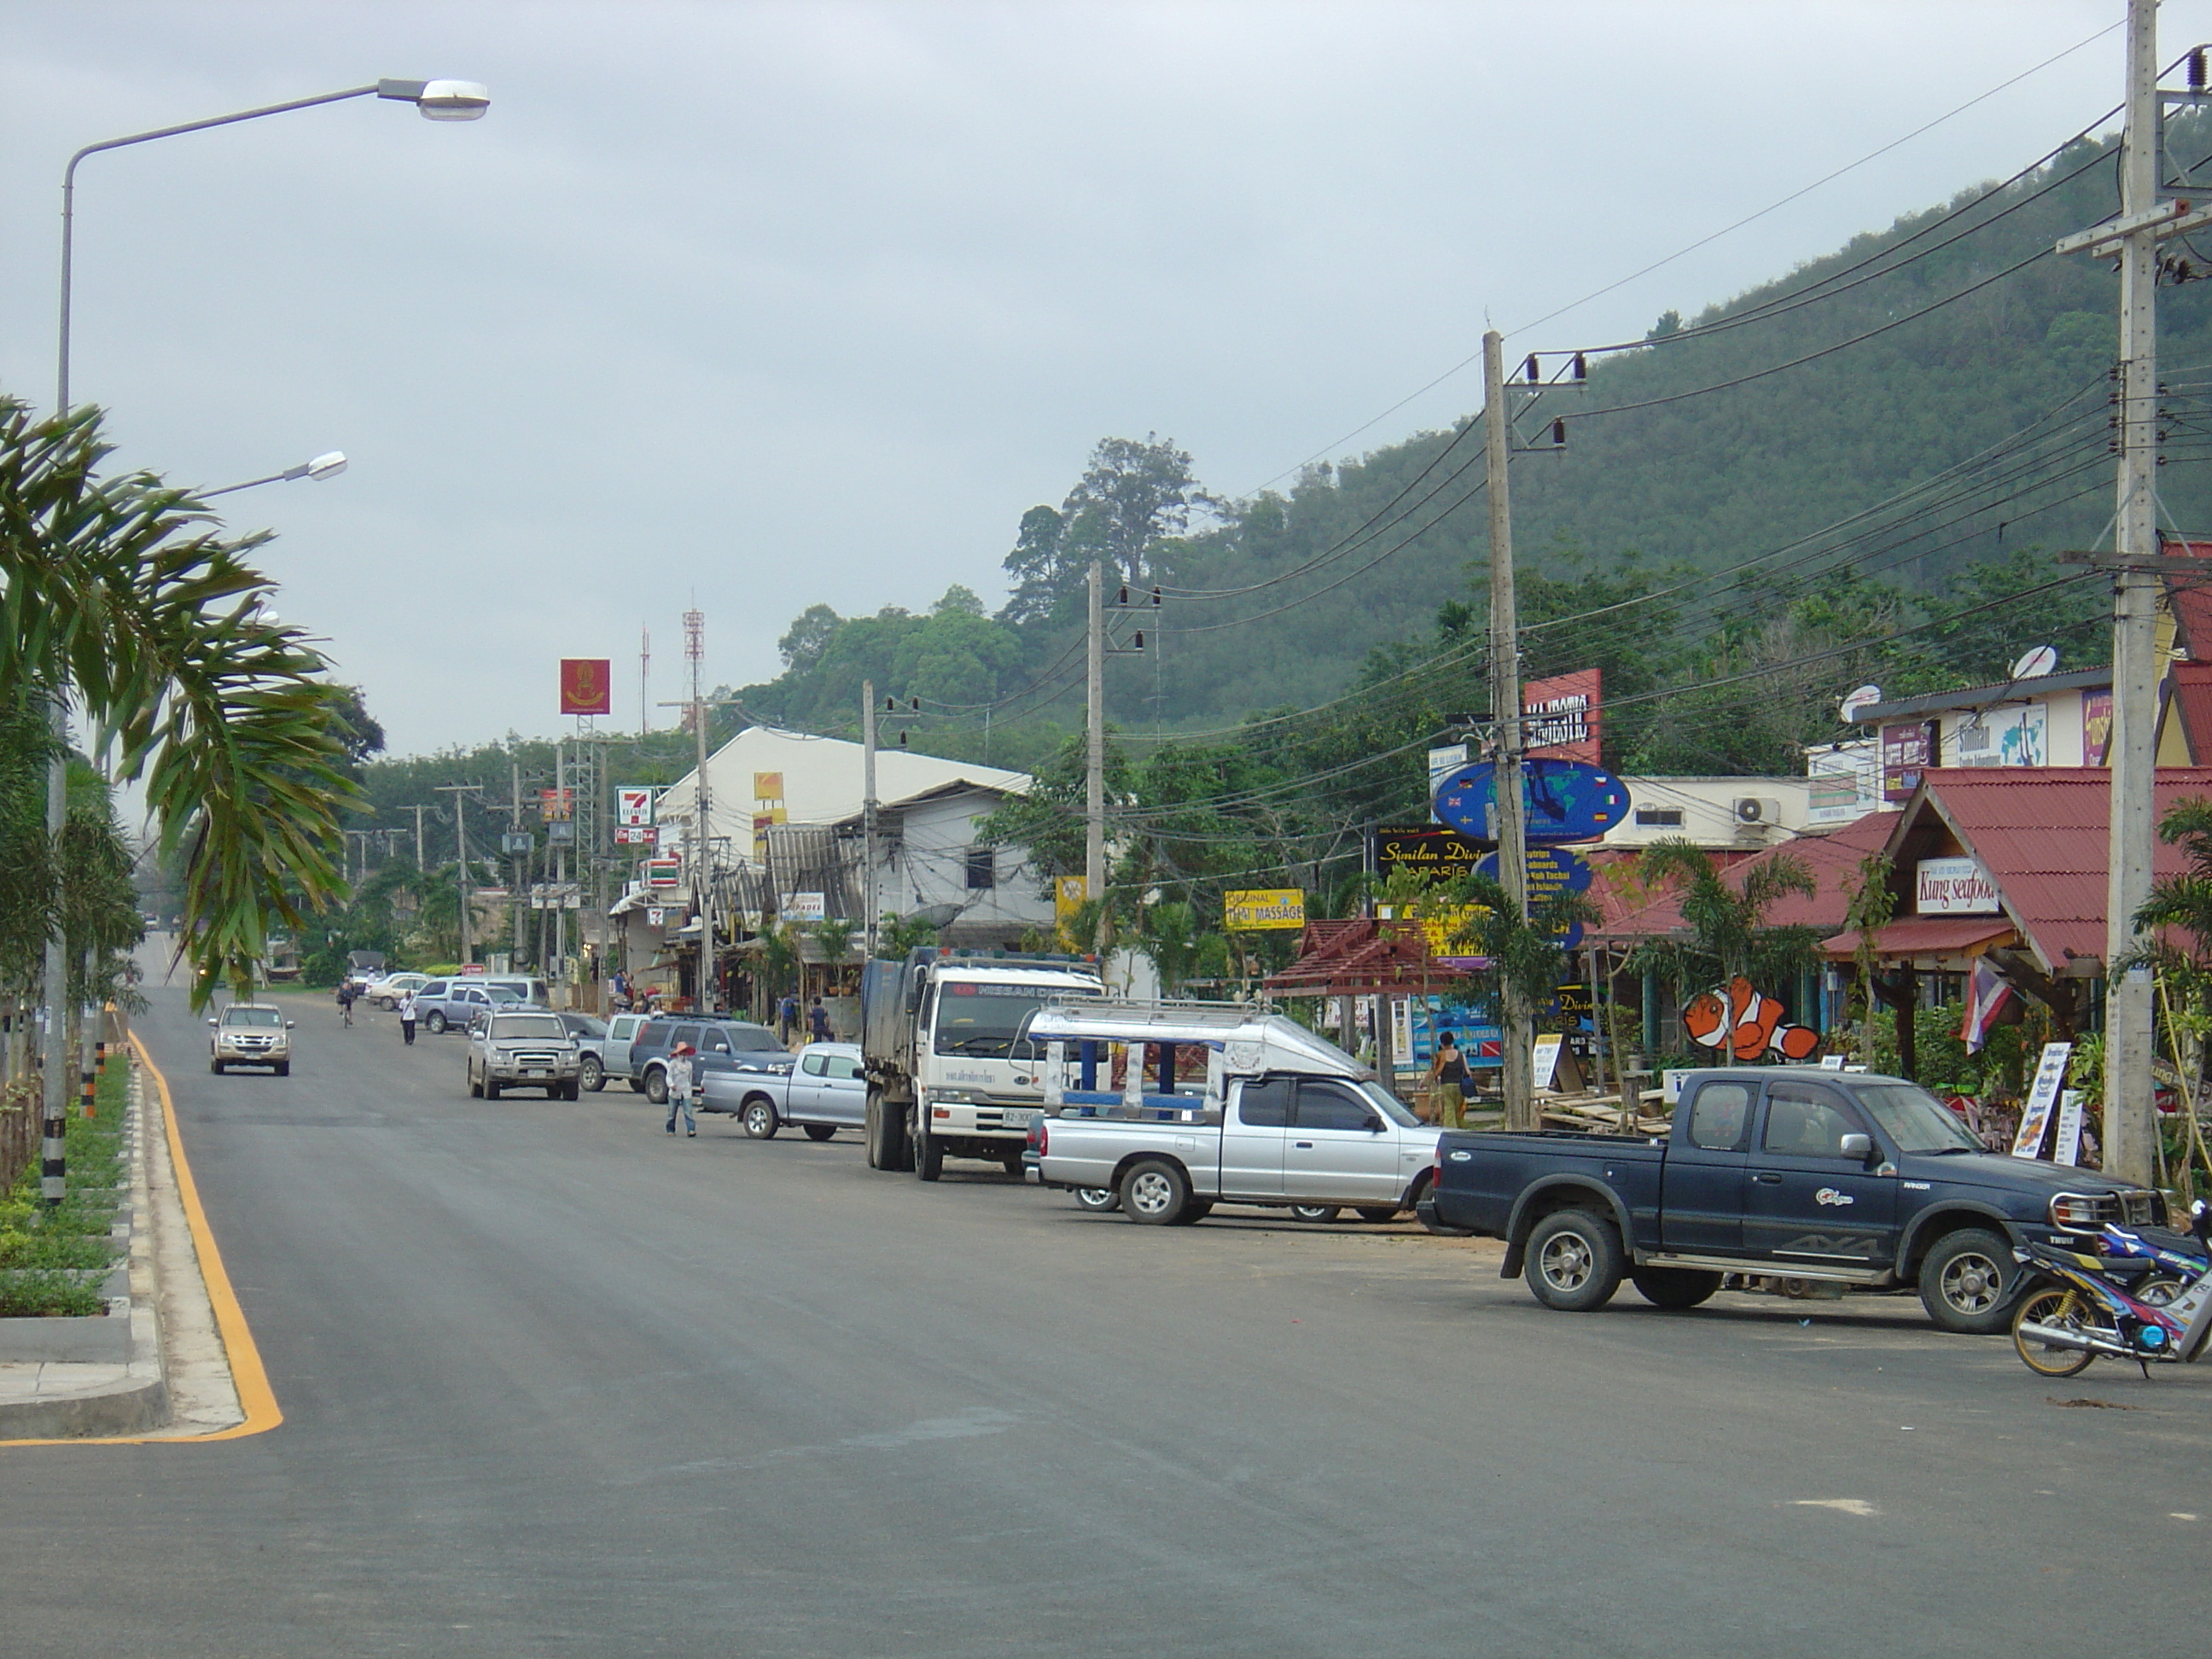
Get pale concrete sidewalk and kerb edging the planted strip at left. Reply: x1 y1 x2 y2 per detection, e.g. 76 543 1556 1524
0 1055 246 1442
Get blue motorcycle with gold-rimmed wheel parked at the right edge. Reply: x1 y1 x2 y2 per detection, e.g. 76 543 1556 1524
2013 1199 2212 1378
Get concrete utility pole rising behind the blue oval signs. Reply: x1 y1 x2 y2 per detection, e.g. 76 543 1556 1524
1486 329 1535 1131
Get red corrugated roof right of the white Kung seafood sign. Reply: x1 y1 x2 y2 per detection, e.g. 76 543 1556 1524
1901 765 2212 973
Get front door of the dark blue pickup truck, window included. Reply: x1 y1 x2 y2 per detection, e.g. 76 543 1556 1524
1743 1081 1898 1266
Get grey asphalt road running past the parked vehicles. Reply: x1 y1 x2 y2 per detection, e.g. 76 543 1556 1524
0 993 2212 1659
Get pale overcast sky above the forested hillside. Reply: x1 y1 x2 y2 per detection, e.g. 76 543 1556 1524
0 0 2185 752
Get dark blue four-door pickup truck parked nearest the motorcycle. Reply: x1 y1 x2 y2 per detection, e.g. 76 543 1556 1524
1423 1066 2166 1334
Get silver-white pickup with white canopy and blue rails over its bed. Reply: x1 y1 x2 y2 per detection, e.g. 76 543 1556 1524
1024 1002 1440 1225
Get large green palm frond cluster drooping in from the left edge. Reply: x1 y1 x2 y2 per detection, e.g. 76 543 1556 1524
0 396 356 1000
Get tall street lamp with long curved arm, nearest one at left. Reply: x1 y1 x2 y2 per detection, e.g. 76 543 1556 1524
38 79 491 1206
